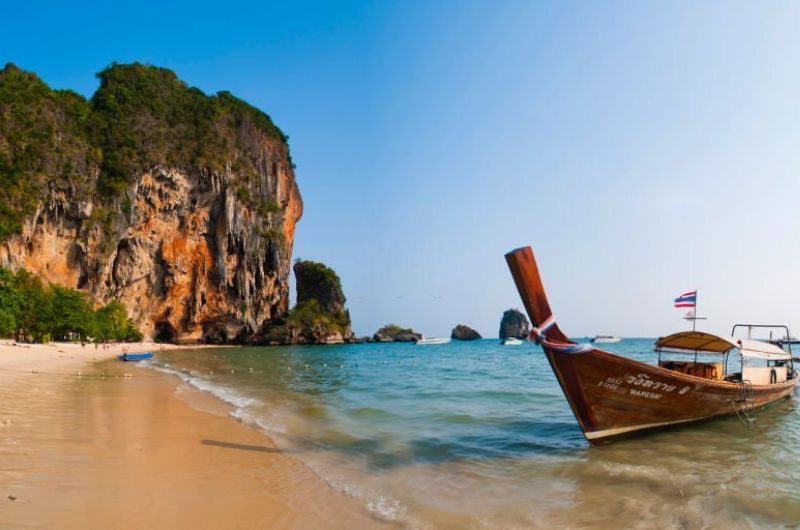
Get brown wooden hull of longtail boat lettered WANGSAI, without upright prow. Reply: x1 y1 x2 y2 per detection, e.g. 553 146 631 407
545 348 797 444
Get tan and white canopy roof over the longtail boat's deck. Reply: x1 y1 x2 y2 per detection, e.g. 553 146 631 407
656 331 792 361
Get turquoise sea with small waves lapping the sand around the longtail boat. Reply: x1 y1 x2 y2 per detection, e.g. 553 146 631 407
149 339 800 529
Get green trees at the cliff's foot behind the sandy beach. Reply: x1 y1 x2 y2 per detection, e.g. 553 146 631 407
0 267 142 342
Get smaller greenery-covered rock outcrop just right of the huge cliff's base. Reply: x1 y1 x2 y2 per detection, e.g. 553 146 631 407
252 260 356 344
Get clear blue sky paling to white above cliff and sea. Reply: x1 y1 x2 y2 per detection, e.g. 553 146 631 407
0 1 800 336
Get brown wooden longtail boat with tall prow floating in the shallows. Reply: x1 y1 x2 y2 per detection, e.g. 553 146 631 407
506 247 798 444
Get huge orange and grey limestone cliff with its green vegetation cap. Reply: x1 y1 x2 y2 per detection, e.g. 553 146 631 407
0 65 303 342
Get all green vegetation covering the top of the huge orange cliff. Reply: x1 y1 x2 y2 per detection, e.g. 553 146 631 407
0 63 288 240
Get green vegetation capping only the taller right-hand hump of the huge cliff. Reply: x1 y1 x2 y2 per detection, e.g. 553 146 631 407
90 63 287 195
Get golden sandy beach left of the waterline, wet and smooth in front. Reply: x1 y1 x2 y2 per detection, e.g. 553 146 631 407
0 346 388 529
